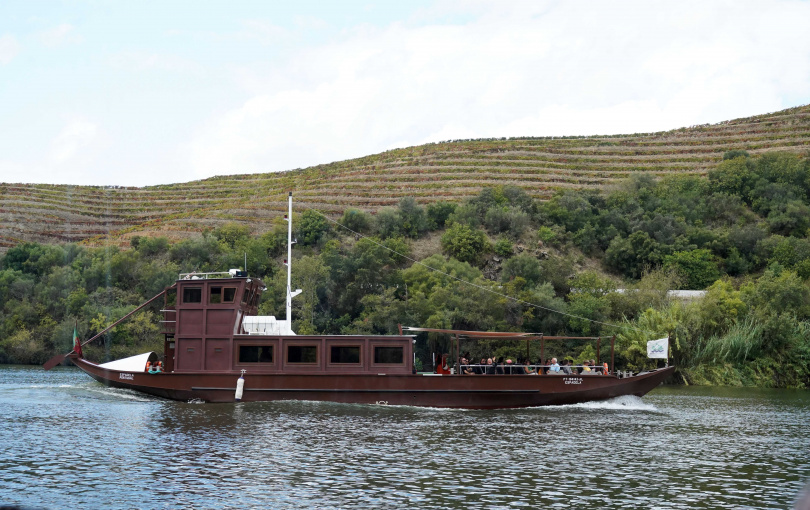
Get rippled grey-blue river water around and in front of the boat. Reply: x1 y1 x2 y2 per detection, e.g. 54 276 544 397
0 366 810 510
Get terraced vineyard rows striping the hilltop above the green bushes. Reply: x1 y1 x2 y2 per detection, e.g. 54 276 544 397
0 105 810 251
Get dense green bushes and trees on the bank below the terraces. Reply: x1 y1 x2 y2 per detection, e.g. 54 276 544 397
0 151 810 388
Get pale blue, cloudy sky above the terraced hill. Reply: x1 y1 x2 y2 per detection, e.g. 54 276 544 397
0 0 810 186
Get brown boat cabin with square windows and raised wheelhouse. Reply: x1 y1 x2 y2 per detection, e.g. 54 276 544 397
162 270 414 374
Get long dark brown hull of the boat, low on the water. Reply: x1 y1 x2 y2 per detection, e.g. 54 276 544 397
72 358 674 409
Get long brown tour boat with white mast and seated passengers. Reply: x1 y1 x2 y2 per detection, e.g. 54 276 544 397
45 196 674 409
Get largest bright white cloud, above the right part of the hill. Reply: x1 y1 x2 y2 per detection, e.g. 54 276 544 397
181 1 810 181
